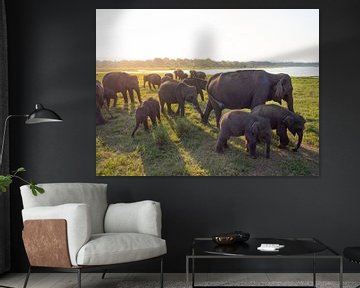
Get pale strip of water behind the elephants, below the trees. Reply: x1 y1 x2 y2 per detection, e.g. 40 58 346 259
134 66 319 77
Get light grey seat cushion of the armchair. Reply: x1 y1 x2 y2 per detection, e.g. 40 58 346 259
77 233 166 265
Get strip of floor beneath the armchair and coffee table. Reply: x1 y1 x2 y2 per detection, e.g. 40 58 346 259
0 273 360 288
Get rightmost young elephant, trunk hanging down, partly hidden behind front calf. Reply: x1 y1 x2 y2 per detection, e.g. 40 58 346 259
251 104 306 152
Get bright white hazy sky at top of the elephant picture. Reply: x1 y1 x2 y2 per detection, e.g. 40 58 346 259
96 9 319 62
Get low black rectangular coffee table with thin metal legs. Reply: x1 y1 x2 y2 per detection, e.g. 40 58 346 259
186 238 343 288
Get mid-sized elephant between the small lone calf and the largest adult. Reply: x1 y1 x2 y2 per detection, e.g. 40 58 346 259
159 80 203 118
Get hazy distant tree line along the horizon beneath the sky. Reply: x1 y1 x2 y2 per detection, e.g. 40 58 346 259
96 58 319 69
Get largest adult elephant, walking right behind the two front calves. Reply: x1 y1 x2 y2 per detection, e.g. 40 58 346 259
202 70 294 127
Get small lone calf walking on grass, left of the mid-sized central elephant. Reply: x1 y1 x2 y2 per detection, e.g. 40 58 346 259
131 97 161 137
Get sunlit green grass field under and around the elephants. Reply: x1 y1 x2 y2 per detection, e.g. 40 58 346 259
96 72 319 176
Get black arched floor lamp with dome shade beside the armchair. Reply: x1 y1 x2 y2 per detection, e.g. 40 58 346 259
0 104 63 288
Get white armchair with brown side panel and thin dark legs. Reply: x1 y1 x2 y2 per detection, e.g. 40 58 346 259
20 183 166 288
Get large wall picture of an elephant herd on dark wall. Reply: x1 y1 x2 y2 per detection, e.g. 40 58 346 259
95 9 319 176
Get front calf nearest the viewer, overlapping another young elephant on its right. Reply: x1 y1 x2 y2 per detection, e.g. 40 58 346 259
216 110 272 159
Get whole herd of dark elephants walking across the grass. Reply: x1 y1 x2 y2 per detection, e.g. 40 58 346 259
96 69 305 158
